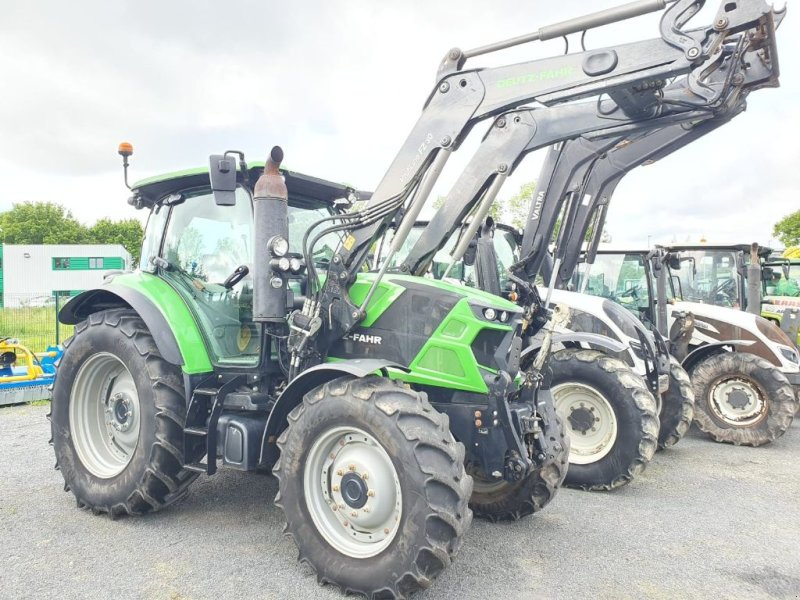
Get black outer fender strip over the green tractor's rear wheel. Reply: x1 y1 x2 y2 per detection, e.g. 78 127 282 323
58 284 184 366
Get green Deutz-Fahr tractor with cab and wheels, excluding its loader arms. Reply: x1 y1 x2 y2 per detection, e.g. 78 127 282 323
51 150 569 596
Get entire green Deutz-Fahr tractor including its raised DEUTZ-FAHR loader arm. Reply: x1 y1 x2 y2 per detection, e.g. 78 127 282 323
52 0 776 598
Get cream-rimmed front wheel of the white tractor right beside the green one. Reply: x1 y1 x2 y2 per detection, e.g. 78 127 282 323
550 349 659 490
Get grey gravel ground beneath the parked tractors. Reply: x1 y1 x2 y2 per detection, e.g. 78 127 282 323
0 406 800 600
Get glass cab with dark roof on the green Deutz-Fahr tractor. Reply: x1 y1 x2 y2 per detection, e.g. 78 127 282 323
121 163 355 367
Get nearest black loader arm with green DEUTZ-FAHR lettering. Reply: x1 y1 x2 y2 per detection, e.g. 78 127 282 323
290 0 774 370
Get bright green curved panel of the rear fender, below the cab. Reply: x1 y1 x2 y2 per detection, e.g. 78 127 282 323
112 272 214 375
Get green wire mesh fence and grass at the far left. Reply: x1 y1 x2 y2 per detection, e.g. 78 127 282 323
0 294 74 352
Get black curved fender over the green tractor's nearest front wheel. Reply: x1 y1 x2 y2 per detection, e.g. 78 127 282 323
260 358 408 465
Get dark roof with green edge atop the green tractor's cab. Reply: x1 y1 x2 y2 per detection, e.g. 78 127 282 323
131 161 357 207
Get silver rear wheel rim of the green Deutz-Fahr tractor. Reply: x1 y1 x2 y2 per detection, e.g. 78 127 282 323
69 352 141 479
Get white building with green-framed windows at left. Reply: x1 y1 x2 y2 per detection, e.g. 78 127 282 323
0 244 132 307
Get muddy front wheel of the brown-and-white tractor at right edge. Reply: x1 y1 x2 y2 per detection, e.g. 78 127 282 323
691 352 798 446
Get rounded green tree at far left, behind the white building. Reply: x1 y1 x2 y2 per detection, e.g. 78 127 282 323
0 202 90 244
